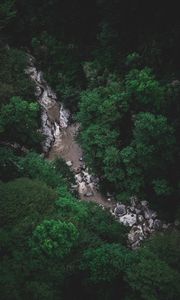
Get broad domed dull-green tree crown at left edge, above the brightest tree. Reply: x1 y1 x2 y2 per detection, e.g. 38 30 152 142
0 178 57 228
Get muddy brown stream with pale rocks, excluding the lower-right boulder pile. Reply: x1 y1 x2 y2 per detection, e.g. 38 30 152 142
26 56 115 208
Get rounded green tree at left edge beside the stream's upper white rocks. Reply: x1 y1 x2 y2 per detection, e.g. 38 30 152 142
0 97 41 147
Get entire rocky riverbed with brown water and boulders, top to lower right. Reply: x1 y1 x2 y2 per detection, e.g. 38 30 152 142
26 55 172 249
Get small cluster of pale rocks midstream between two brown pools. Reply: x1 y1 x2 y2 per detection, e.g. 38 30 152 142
66 157 99 197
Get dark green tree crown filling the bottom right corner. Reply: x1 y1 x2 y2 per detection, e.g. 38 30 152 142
126 251 180 300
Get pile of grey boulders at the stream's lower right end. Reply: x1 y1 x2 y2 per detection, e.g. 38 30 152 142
113 197 171 249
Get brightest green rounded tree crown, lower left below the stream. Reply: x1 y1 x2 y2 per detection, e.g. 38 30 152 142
31 220 78 259
